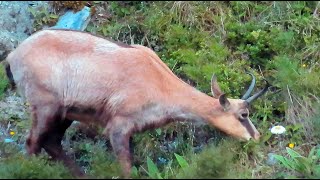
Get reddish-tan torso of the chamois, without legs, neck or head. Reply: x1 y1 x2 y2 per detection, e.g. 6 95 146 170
7 30 188 117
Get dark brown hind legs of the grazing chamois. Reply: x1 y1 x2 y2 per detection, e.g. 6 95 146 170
26 103 82 176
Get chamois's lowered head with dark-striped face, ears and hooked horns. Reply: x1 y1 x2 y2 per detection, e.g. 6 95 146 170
211 73 269 140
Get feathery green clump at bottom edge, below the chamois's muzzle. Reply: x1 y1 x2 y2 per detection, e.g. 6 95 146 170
176 139 254 179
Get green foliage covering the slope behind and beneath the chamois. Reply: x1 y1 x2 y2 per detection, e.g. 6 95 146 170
0 1 320 178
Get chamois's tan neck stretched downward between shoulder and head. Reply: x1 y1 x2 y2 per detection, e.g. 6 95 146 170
131 86 220 134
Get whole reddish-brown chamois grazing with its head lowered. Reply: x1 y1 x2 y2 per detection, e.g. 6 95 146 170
6 29 269 177
